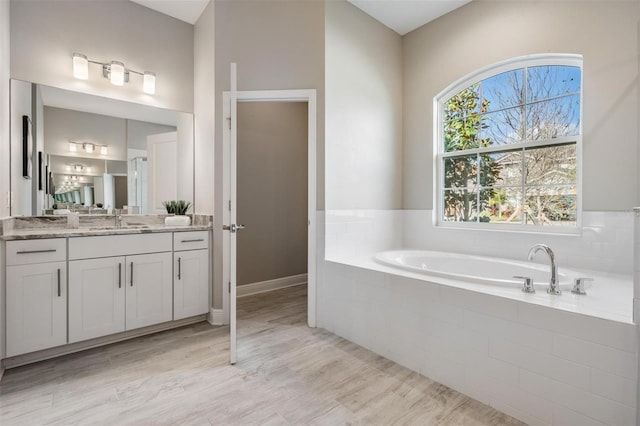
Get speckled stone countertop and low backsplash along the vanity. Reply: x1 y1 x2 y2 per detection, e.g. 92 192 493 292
0 215 213 241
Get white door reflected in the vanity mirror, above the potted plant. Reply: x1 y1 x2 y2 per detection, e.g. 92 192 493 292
147 132 178 214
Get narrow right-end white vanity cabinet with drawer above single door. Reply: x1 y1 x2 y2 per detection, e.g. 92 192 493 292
173 231 209 320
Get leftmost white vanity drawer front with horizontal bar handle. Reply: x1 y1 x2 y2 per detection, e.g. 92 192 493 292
7 238 67 266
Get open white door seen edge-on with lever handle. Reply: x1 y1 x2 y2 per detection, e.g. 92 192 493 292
222 63 239 364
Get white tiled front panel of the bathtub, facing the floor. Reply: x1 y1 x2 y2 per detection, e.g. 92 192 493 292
318 261 638 425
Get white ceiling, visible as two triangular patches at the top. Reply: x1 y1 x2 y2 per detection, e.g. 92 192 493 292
131 0 471 35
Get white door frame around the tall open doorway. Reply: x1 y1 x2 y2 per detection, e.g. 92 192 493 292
220 89 317 328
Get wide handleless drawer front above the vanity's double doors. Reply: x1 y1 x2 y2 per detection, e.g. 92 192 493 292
69 232 171 260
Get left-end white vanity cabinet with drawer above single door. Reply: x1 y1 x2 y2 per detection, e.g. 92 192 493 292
6 238 67 357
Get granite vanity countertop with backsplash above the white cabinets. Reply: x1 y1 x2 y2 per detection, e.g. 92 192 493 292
0 215 213 241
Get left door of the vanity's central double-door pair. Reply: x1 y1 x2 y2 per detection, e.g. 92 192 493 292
69 256 125 343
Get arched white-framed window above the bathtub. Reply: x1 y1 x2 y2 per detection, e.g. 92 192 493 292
436 55 582 232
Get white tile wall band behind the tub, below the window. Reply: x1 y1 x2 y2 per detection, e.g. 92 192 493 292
325 210 640 276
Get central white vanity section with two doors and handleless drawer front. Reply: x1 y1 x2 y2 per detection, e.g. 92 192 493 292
69 232 173 342
